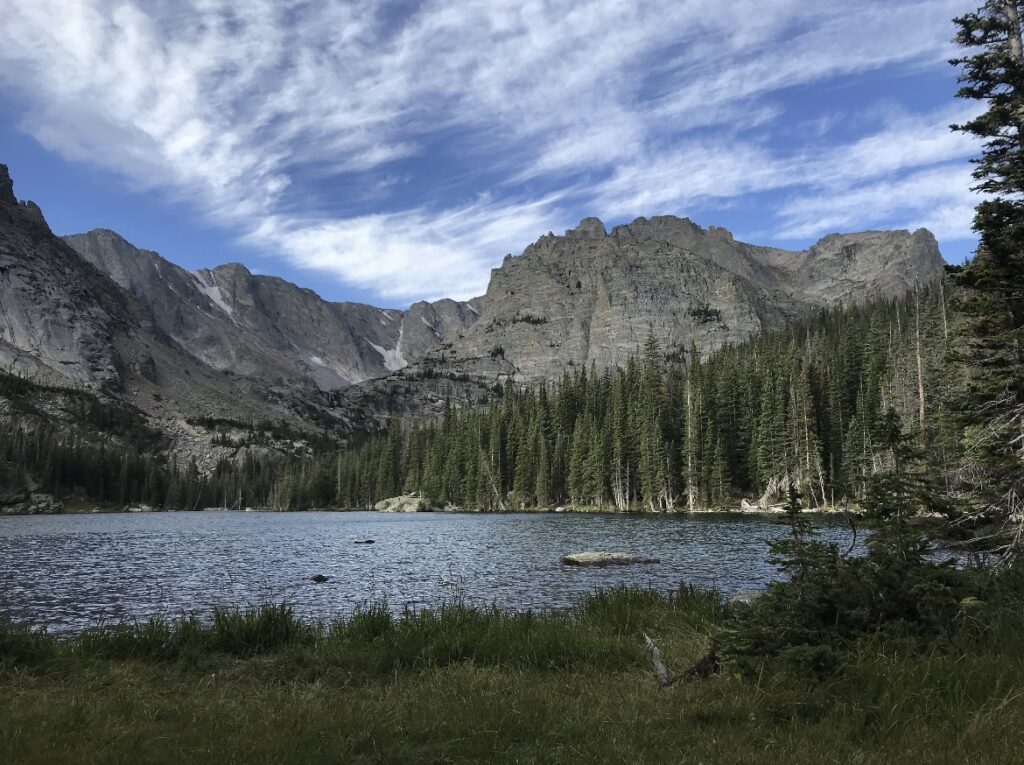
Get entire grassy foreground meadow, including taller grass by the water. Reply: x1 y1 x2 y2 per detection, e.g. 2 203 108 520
0 589 1024 765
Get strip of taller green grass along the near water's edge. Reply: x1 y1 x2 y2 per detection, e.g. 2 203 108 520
0 588 722 673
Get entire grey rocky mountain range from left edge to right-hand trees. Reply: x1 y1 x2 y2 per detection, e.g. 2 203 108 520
0 166 943 452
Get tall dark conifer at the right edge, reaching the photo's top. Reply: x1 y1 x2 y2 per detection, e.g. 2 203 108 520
952 0 1024 556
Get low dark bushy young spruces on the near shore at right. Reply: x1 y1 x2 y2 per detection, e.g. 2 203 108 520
722 410 978 673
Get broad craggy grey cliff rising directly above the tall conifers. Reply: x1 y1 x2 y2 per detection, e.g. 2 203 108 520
382 216 943 383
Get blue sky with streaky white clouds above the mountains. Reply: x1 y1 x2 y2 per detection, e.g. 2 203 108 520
0 0 978 307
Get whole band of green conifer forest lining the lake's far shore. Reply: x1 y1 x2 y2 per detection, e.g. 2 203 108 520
0 285 958 510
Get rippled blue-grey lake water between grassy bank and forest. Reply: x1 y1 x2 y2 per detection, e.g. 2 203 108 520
0 512 849 632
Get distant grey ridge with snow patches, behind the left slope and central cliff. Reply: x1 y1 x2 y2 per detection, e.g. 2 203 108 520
63 229 479 390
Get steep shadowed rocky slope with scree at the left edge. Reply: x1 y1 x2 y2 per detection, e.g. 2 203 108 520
0 165 349 445
